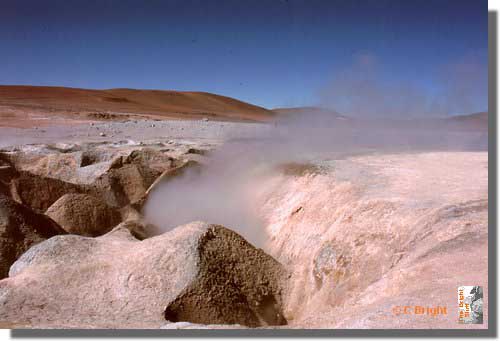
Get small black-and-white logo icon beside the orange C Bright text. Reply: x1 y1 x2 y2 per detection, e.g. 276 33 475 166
457 285 483 324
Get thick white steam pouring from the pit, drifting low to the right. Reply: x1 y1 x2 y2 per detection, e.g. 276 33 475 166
145 112 487 248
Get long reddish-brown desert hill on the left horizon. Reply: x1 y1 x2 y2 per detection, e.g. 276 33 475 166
0 85 273 126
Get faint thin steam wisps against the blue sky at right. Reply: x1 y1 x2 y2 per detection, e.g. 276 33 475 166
319 53 488 118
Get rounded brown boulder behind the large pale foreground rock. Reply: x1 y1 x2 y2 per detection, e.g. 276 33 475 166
46 194 121 237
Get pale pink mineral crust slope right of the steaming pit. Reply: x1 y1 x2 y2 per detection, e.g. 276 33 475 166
259 152 488 328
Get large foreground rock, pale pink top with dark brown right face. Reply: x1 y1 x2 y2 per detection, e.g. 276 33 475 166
0 222 286 328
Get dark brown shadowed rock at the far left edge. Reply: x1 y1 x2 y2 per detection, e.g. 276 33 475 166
0 194 66 278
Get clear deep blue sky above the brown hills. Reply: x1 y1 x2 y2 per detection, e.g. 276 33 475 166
0 0 487 111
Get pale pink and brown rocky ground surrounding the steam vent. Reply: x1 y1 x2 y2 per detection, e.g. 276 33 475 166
0 120 488 328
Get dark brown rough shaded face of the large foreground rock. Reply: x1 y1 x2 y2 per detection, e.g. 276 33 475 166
165 226 286 327
